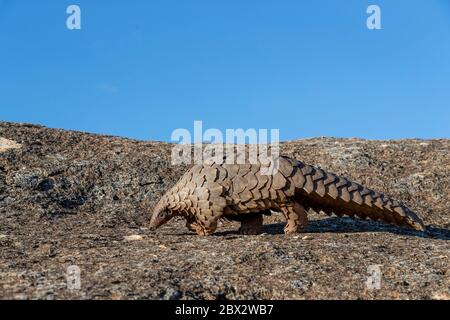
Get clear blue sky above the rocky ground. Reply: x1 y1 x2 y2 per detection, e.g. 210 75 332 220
0 0 450 141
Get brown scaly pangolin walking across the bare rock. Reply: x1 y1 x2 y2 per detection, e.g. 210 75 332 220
150 156 424 235
